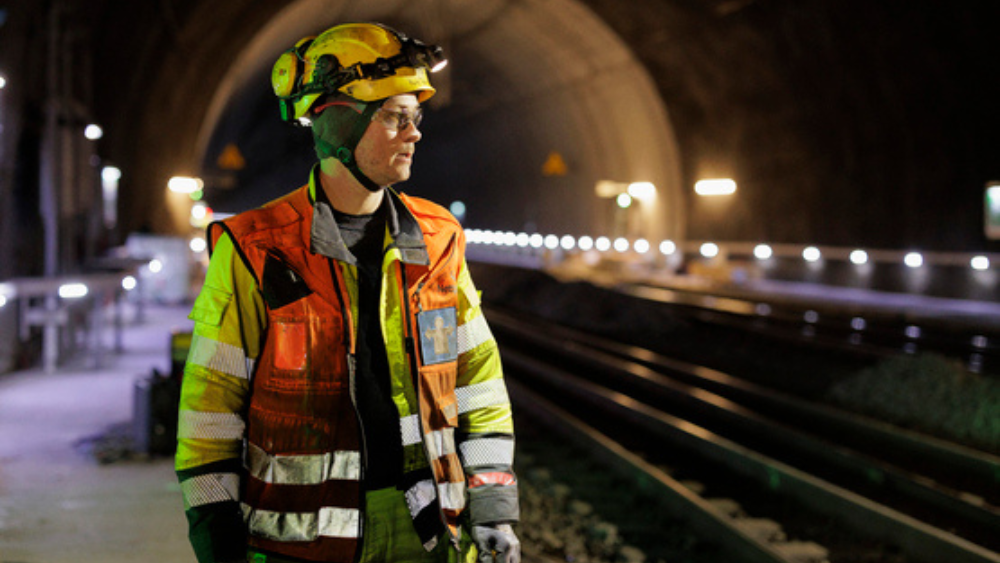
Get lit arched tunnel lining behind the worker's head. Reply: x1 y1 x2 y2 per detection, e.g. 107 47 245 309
196 0 684 238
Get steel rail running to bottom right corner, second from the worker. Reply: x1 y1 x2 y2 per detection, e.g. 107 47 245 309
504 347 1000 563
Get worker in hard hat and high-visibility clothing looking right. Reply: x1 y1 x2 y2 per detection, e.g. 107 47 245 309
176 24 520 563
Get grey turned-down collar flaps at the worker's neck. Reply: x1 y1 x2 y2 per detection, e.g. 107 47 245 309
309 164 430 266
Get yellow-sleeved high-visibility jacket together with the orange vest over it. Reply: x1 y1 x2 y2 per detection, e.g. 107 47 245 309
176 169 518 563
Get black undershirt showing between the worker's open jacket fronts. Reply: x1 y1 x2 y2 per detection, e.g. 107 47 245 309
331 204 403 490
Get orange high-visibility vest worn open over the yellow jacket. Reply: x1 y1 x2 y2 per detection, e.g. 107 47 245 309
210 187 465 563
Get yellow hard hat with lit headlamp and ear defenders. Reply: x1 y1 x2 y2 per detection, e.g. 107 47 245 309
271 23 446 122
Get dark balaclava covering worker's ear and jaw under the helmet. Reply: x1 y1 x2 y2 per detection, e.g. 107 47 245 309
312 95 382 192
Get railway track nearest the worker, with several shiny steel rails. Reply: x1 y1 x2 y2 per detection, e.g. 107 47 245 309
489 310 1000 563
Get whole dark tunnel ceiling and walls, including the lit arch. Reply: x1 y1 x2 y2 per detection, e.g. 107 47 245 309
9 0 1000 258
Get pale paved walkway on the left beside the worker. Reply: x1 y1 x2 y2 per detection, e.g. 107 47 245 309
0 307 195 563
